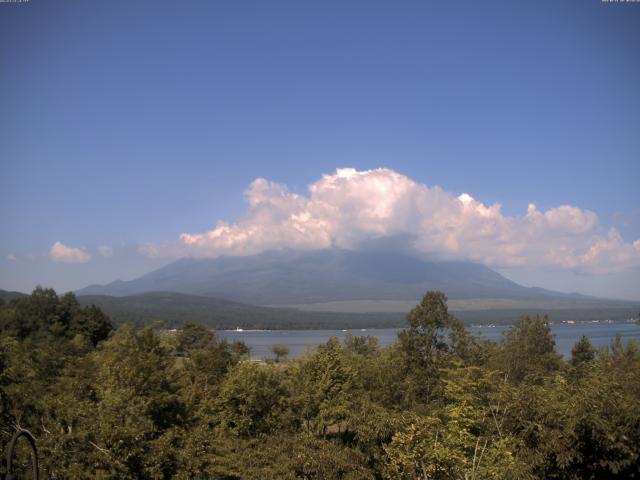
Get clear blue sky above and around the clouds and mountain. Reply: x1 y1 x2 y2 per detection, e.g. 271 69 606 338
0 0 640 299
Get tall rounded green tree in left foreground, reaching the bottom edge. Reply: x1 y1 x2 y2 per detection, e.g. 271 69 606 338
92 327 185 478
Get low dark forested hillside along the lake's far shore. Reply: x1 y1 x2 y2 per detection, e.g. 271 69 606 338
78 292 638 329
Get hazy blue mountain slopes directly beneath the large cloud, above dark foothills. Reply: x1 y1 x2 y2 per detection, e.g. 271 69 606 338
77 248 600 305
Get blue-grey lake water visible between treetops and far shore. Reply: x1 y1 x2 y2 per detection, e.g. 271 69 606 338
217 322 640 358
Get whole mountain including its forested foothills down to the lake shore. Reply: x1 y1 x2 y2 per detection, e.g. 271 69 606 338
0 253 640 329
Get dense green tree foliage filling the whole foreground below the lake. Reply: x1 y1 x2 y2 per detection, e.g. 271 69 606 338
0 289 640 480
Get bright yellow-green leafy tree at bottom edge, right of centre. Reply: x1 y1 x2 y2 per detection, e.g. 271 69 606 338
385 364 528 480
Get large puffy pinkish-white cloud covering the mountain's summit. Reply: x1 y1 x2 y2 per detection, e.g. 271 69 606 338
180 168 640 273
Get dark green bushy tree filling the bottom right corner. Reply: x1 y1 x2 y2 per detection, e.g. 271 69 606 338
506 362 640 480
